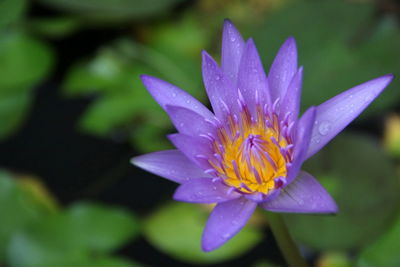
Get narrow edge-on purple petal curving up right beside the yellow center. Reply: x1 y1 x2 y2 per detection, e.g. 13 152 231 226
287 107 317 184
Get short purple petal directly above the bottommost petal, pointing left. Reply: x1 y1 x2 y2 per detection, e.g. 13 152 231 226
174 178 241 204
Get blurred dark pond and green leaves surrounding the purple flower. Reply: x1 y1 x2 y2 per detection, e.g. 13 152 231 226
0 0 400 267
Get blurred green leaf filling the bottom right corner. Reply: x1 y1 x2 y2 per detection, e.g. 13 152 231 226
357 214 400 267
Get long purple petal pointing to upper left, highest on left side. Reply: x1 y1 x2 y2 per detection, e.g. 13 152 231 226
140 75 214 119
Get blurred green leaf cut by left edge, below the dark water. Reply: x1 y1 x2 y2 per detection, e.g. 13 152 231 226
0 170 48 262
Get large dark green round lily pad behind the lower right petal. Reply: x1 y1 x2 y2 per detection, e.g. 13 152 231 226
285 134 400 250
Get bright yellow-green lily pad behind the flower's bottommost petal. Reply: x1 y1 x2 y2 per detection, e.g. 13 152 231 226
144 202 262 264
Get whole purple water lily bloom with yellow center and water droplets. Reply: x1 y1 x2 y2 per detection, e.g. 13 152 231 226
132 20 393 251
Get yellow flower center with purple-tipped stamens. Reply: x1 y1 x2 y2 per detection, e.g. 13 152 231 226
210 107 293 194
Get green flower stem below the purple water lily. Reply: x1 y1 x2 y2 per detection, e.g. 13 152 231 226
268 212 308 267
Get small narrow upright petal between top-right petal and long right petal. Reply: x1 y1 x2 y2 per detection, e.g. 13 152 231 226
280 67 303 120
